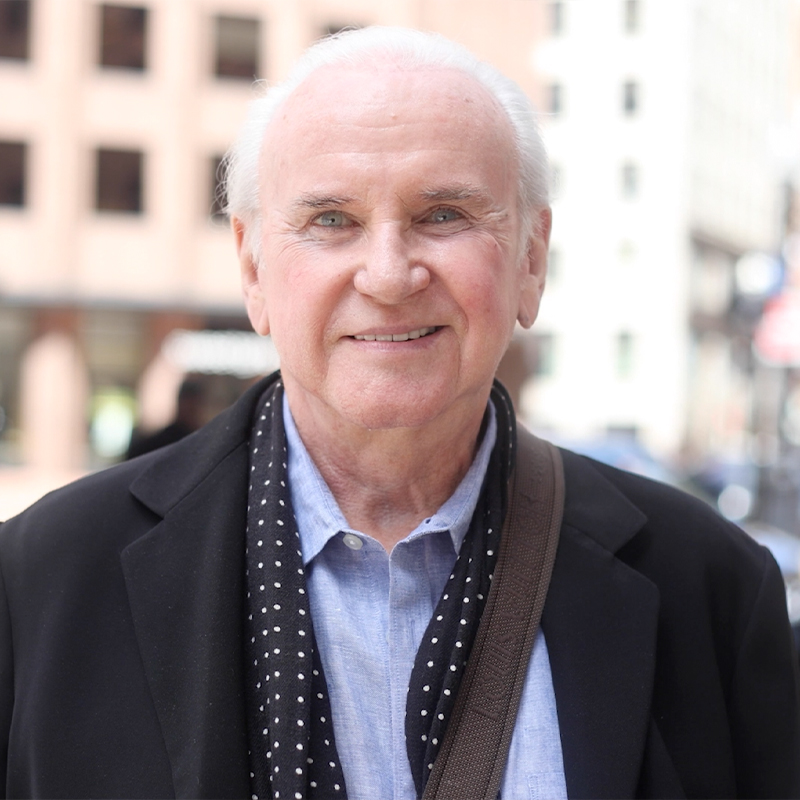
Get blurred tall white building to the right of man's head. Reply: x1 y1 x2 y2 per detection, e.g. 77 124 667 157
526 0 798 468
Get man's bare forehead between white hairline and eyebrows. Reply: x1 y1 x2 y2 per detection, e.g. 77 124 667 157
263 62 516 191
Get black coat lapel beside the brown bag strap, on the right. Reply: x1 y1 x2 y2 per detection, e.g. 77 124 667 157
542 453 659 798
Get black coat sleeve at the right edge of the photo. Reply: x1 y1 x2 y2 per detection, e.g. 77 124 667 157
729 554 800 798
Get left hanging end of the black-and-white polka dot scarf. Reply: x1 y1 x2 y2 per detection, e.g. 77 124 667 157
245 381 346 800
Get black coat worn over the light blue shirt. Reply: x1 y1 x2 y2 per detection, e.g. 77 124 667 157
0 376 800 800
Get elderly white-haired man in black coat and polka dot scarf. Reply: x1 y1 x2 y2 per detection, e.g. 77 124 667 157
0 29 800 799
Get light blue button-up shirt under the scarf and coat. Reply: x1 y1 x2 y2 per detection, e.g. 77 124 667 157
283 396 567 800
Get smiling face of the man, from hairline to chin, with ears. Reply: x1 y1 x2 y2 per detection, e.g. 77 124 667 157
234 65 549 438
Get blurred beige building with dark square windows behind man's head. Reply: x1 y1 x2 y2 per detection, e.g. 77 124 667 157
0 0 543 490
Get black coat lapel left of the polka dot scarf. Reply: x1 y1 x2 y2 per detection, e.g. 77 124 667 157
121 376 276 797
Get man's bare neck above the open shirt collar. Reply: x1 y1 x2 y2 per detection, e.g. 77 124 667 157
287 392 488 552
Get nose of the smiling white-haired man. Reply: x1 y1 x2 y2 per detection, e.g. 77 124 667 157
353 223 430 305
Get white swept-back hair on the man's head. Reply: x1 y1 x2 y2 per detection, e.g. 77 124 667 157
224 26 549 263
